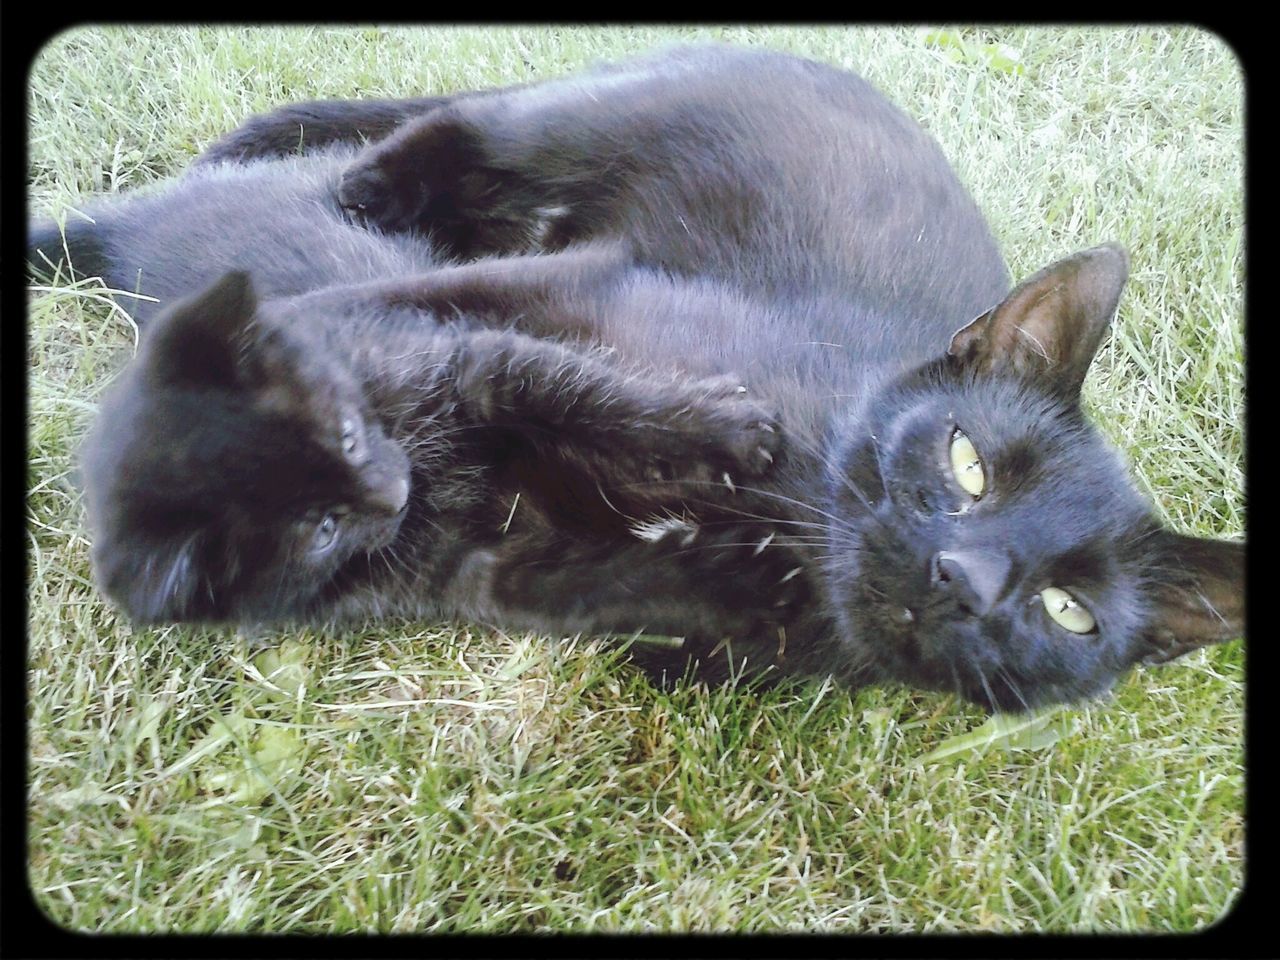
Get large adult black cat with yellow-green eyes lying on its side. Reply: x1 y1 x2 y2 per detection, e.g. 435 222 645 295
35 49 1243 709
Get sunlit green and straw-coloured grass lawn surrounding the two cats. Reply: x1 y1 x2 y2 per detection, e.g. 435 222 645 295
27 28 1244 933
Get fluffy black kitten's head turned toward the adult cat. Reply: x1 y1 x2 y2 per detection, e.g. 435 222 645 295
83 273 410 622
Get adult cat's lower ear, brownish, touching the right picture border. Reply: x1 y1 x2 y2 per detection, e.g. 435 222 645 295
1139 530 1244 663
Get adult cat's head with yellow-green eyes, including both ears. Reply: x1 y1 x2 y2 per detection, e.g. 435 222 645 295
828 246 1244 710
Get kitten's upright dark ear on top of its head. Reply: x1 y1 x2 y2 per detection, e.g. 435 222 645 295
145 271 257 385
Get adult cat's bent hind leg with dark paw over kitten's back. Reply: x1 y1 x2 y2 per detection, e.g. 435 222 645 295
338 74 665 257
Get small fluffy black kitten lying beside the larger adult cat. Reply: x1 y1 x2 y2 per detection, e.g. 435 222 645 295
29 148 780 632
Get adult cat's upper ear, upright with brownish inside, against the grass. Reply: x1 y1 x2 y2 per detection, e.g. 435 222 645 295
947 243 1129 397
